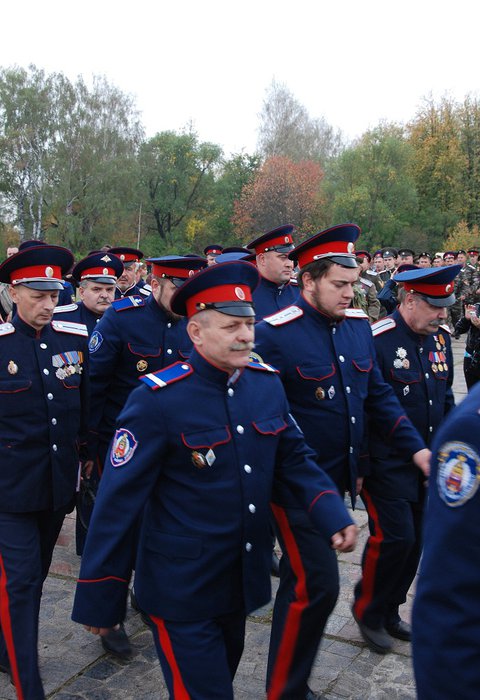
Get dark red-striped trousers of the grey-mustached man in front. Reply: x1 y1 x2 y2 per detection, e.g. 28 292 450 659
150 611 245 700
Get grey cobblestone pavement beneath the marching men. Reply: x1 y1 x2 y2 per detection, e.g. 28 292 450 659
0 340 466 700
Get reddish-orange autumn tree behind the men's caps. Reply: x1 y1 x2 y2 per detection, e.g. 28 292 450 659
233 156 323 239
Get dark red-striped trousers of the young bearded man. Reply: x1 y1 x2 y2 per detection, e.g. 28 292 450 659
267 506 339 700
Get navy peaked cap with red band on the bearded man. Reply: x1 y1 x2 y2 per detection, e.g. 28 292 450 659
288 224 360 268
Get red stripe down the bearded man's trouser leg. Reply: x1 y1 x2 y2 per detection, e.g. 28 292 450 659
267 503 309 700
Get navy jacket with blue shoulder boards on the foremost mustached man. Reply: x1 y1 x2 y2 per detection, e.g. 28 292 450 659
73 350 351 627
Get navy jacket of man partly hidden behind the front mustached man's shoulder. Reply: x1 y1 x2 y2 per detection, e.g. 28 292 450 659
89 295 191 448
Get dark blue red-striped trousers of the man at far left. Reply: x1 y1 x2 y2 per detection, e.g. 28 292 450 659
0 508 71 700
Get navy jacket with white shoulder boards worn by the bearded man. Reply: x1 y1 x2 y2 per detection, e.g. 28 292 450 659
255 296 425 501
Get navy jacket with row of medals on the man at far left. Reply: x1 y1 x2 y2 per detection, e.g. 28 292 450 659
0 315 88 512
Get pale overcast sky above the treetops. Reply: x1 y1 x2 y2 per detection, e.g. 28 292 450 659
0 0 480 154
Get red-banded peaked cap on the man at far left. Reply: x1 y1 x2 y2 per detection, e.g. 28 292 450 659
0 244 74 292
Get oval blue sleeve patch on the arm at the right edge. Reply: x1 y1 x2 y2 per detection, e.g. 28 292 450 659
437 442 480 508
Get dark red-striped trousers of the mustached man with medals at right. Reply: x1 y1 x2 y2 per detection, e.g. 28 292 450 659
354 488 423 629
